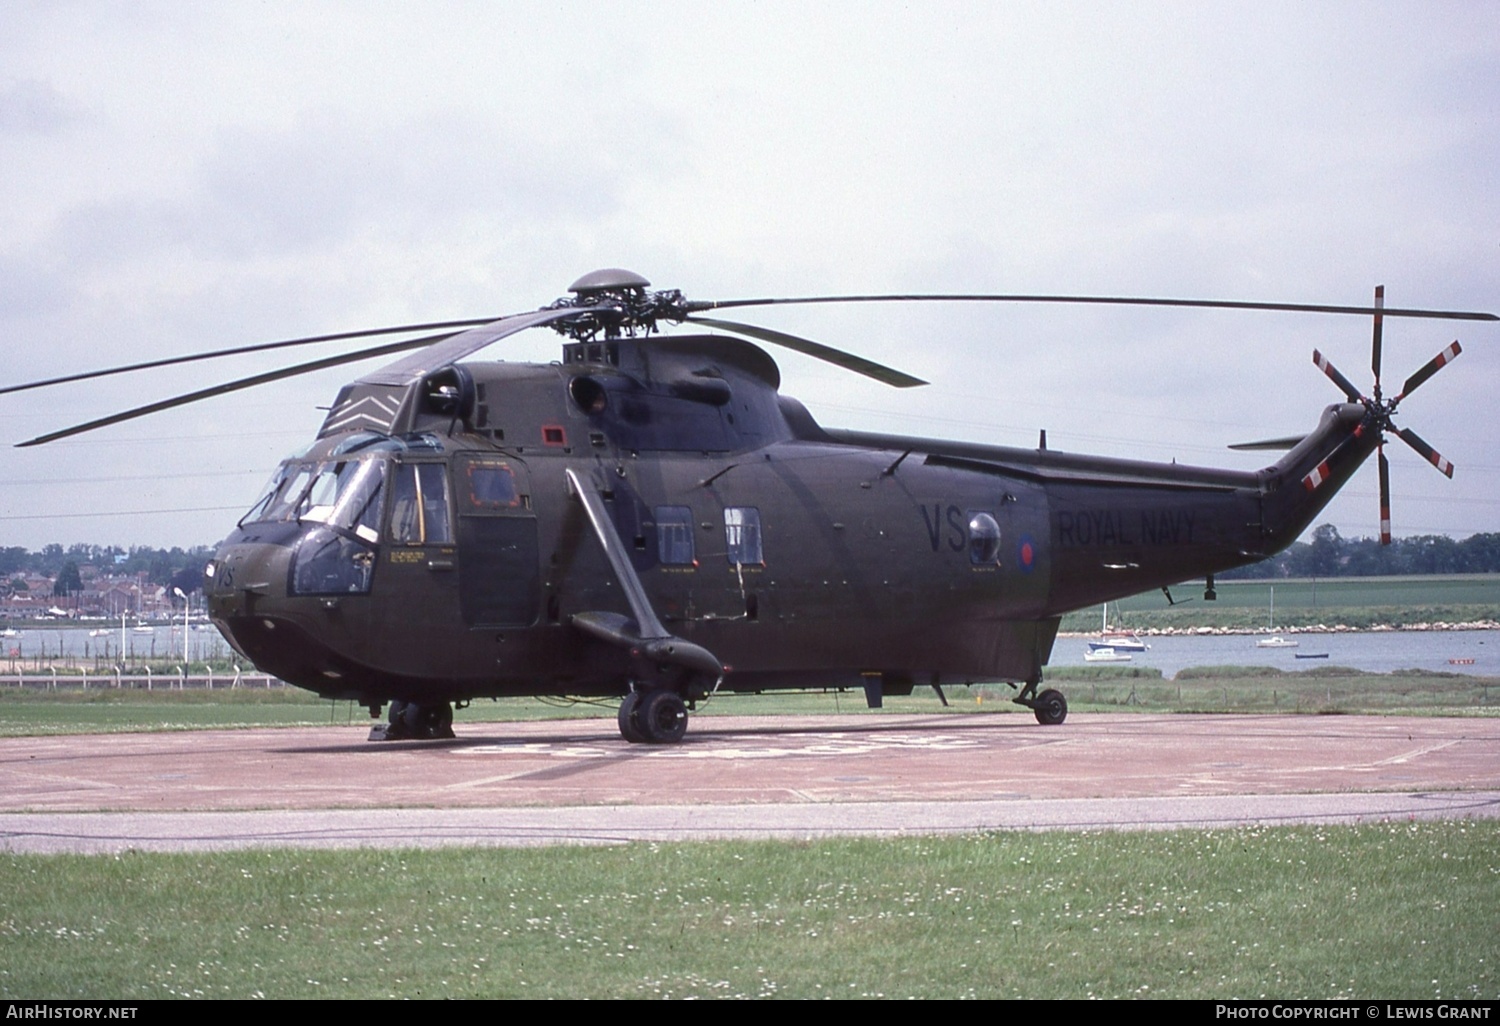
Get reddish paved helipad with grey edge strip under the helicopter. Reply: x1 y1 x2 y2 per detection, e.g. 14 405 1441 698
0 714 1500 851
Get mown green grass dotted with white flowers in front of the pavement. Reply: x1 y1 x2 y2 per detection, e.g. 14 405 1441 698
0 822 1500 1001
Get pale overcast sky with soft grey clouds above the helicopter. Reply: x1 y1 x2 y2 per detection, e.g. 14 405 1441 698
0 0 1500 549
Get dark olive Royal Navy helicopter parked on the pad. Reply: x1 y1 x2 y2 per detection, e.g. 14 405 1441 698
0 269 1497 744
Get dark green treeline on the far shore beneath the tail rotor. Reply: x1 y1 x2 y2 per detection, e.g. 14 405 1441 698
1218 524 1500 581
